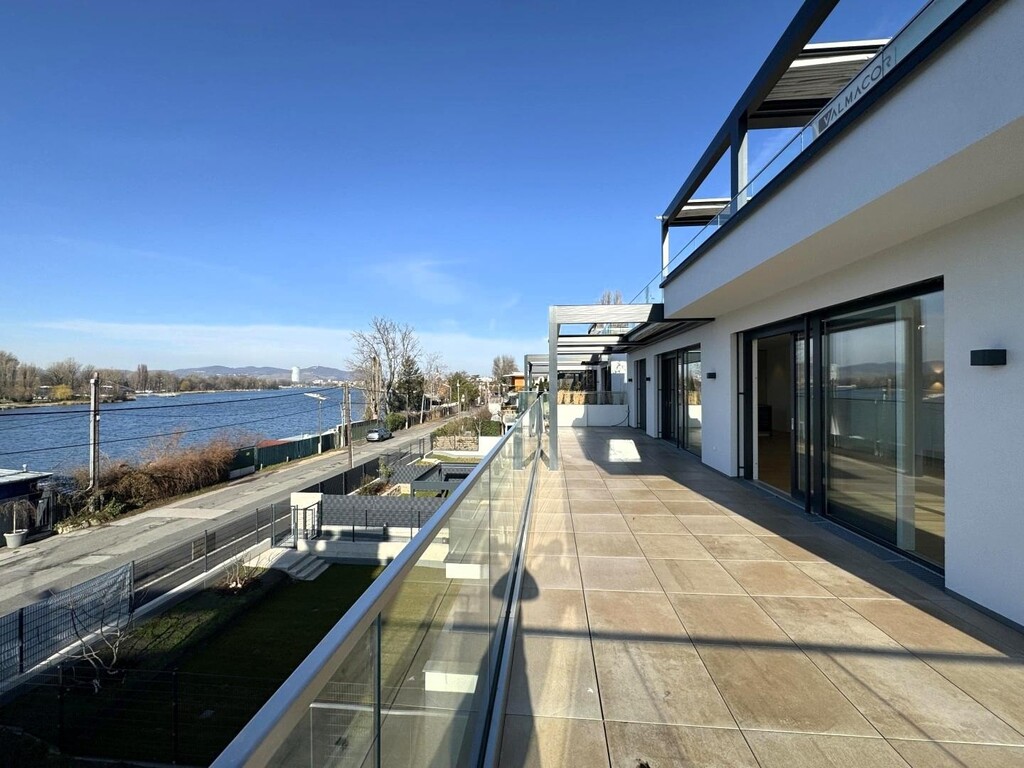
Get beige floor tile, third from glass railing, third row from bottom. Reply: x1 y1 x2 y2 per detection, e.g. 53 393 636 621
669 594 796 648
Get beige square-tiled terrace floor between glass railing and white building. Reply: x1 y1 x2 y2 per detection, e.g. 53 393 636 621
501 429 1024 768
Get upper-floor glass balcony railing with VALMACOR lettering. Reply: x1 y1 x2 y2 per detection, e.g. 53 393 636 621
630 0 966 304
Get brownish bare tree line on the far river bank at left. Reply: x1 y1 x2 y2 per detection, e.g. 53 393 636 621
0 350 280 402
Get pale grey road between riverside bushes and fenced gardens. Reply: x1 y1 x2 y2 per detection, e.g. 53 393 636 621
0 421 443 615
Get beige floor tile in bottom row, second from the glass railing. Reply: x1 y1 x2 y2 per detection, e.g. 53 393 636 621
602 722 758 768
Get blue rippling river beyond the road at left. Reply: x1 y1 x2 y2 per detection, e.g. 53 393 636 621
0 387 364 473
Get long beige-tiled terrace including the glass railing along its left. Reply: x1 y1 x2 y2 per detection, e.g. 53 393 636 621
215 404 1024 768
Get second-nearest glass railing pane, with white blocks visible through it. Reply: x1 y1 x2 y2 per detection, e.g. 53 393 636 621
381 461 494 766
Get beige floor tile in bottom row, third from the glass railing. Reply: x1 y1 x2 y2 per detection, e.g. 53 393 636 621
743 731 906 768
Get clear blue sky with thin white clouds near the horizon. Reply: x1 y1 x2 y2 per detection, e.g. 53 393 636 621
0 0 923 373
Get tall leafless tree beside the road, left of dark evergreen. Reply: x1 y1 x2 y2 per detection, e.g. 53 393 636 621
347 317 420 419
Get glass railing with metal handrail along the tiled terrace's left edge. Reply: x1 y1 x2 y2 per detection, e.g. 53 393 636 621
213 397 546 768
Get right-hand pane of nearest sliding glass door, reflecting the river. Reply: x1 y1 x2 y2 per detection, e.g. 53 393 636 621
822 292 945 565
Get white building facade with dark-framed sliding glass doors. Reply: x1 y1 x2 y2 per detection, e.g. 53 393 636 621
628 0 1024 625
